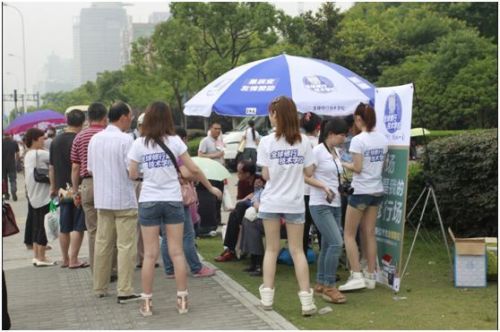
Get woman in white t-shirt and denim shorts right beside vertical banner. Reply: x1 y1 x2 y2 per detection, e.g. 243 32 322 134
339 104 387 291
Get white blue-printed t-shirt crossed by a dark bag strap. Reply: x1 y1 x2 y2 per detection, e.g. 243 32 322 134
128 136 187 203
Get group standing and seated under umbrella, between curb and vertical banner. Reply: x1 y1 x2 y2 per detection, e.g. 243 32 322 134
209 97 387 316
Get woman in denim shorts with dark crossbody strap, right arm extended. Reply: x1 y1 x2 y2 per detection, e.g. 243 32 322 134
128 102 222 316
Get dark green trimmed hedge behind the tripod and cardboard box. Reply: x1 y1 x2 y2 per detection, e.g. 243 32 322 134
407 129 498 237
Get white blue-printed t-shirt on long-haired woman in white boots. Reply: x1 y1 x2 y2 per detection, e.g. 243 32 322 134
257 133 313 213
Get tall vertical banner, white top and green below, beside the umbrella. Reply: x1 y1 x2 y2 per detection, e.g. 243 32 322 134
375 84 413 291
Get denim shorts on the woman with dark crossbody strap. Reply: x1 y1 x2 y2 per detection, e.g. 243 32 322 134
139 202 184 226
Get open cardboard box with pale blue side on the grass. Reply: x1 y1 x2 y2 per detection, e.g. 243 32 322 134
448 228 488 287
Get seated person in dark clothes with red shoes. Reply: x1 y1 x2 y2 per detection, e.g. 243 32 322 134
215 161 256 262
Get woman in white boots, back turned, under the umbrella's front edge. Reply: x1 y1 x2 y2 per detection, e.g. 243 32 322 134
257 96 316 316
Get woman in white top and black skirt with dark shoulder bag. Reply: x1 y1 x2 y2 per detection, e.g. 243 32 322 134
24 128 56 267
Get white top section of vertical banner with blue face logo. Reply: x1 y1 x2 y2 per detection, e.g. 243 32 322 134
375 84 413 146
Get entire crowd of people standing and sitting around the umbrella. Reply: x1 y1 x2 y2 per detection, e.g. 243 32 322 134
3 96 387 316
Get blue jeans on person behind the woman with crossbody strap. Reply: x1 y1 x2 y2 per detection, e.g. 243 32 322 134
160 207 202 274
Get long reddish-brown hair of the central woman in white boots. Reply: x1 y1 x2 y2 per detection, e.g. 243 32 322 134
268 96 302 145
